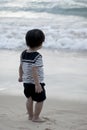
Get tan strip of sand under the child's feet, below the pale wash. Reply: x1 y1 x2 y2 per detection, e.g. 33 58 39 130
0 95 87 130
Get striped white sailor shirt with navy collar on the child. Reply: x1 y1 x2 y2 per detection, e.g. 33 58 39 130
21 50 44 84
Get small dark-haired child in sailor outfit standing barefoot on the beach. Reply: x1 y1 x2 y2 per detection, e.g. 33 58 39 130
19 29 46 122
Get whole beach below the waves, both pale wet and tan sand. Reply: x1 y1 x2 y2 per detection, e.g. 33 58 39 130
0 50 87 130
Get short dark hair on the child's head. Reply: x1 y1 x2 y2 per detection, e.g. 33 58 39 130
25 29 45 48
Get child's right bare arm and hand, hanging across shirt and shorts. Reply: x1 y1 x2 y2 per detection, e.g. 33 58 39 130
32 67 43 93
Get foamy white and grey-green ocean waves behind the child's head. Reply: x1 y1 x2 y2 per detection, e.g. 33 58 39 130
0 0 87 51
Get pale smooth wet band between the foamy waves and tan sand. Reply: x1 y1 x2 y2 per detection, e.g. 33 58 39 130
0 49 87 102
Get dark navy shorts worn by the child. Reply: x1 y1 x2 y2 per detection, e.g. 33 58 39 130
23 83 46 102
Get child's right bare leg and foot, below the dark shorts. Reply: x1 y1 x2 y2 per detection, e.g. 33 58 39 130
32 102 43 122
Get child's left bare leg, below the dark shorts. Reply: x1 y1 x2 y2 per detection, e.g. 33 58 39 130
26 97 33 120
